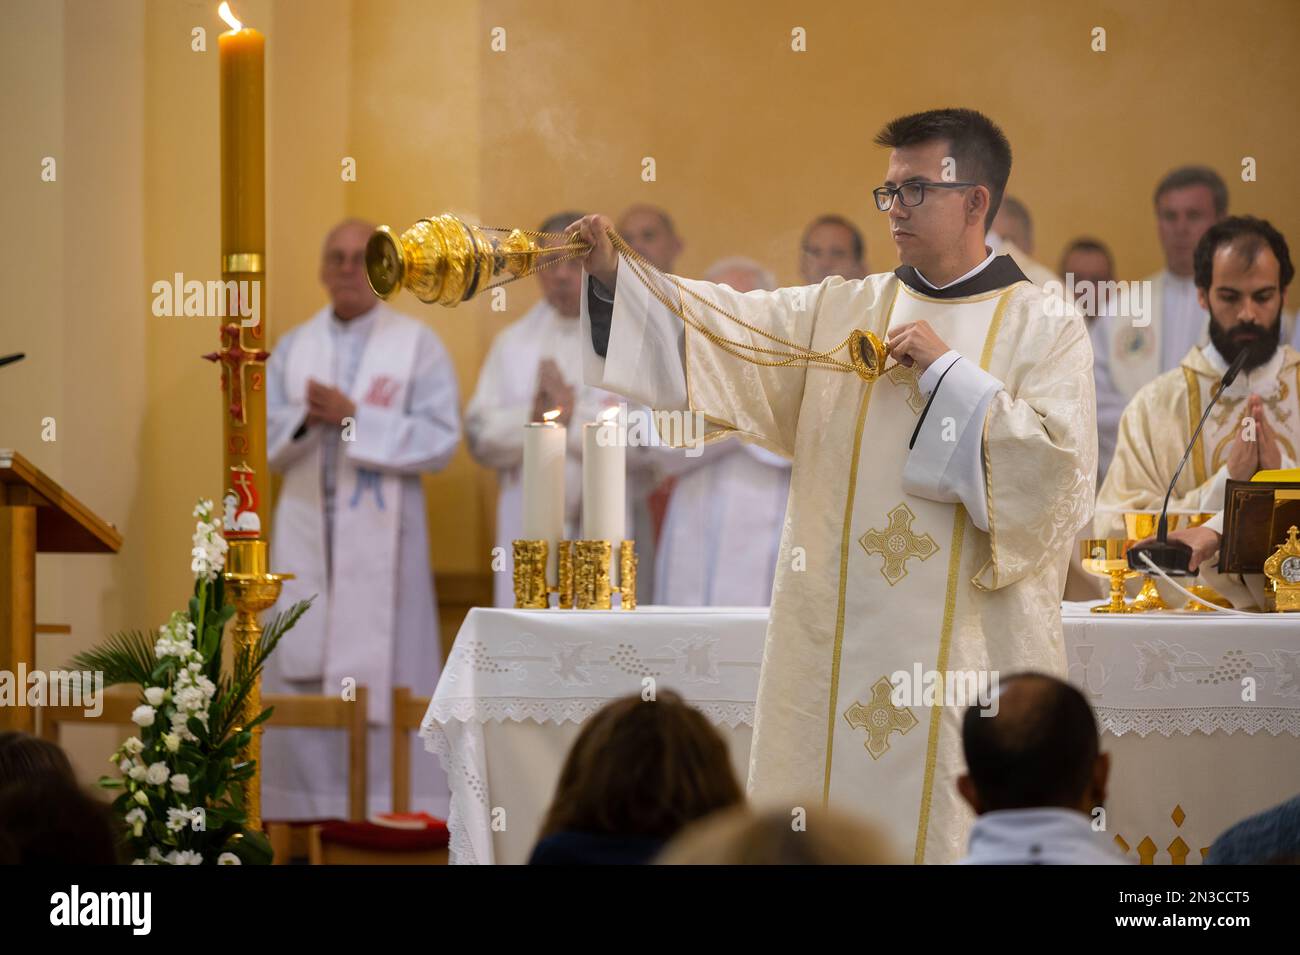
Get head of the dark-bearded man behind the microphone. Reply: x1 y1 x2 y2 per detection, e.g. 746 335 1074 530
1193 216 1295 370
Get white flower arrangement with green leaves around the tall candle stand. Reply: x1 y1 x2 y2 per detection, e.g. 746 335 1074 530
72 500 311 865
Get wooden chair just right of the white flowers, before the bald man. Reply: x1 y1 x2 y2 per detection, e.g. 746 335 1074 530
261 686 368 865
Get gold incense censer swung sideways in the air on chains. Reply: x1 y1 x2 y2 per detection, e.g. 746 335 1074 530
365 213 588 308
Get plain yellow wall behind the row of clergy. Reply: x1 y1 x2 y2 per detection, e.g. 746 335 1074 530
0 0 1300 784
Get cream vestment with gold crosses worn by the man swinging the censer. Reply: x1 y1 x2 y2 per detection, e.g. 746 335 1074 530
584 256 1096 863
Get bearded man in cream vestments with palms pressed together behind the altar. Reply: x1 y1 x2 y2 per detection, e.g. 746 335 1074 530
1096 216 1300 603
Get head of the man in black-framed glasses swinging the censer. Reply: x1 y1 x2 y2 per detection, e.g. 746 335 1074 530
875 109 1011 283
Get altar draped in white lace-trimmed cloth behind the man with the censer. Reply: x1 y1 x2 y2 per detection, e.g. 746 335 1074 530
420 613 1300 864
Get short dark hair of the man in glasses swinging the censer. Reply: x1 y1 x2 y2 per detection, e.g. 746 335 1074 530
875 109 1011 231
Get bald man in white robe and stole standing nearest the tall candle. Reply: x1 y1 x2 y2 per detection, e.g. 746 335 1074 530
261 220 460 819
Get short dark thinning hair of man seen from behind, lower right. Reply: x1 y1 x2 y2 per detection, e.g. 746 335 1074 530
962 673 1100 811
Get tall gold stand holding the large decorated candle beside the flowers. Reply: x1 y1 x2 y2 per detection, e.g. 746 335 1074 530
222 541 294 829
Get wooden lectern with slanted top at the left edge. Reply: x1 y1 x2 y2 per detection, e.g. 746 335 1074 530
0 448 122 733
